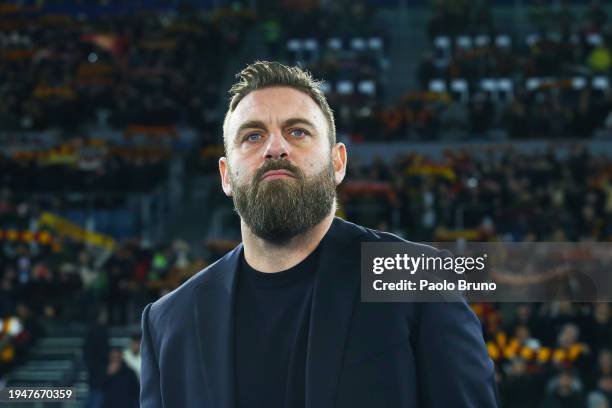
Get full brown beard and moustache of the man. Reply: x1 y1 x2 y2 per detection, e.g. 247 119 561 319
230 160 336 244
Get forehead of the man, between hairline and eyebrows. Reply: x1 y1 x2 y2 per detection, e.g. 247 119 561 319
227 87 326 136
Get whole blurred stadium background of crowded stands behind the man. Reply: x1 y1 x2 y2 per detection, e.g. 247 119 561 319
0 0 612 408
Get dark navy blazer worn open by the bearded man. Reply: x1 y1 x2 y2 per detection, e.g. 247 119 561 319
140 218 497 408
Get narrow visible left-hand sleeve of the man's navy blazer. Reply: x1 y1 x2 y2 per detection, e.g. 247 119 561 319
140 304 164 408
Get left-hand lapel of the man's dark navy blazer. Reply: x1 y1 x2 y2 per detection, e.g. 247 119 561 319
194 244 242 408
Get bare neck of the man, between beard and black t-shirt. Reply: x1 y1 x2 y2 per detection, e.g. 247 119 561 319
240 211 335 273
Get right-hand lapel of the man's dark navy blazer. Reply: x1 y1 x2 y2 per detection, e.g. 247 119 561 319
306 218 360 408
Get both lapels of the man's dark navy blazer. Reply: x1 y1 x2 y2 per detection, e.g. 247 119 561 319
194 218 364 408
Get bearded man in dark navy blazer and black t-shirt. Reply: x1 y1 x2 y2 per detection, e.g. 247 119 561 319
141 62 497 408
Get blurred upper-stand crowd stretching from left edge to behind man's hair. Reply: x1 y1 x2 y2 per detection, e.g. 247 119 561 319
0 2 388 141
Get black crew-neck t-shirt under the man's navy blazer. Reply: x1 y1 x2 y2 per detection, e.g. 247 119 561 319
234 249 319 408
